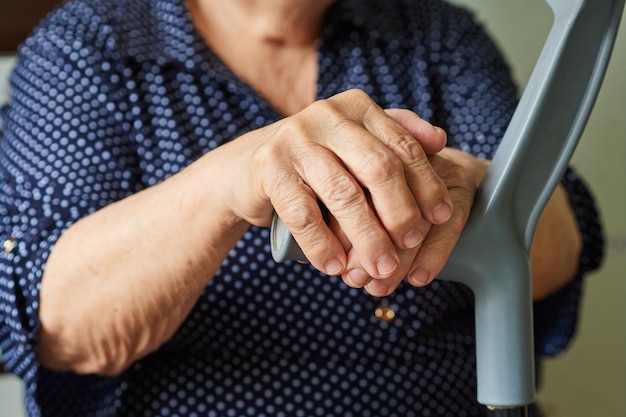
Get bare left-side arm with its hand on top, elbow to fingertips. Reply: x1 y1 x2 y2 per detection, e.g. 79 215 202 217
37 91 451 375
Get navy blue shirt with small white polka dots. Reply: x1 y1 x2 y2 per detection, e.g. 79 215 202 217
0 0 602 417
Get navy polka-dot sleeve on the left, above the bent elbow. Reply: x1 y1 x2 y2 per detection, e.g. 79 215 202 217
0 3 140 380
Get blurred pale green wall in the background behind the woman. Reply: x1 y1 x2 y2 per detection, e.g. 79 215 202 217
0 0 626 417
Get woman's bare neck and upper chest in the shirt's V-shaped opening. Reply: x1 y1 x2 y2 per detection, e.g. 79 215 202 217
188 0 334 116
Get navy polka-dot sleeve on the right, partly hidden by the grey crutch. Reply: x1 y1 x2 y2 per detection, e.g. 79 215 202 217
431 4 604 355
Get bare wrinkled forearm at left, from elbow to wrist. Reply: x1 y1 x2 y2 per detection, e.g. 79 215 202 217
38 149 248 374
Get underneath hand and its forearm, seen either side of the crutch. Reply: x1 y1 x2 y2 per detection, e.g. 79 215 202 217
334 143 582 300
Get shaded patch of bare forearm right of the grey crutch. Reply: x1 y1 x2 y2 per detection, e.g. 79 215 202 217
531 185 582 300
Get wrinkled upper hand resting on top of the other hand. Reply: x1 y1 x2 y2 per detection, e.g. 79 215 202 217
230 90 453 279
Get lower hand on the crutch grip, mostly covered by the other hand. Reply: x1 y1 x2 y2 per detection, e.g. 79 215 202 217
332 148 489 296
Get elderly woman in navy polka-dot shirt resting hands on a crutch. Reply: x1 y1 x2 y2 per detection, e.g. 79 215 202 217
0 0 602 417
